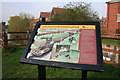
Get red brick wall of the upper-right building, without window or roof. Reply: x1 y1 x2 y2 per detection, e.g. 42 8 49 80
106 2 120 34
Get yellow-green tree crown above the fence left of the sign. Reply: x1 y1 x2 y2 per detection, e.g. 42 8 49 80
8 13 33 31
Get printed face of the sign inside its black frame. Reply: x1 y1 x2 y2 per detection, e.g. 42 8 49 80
27 25 97 65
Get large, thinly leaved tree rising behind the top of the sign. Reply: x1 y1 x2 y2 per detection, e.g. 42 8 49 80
51 2 99 21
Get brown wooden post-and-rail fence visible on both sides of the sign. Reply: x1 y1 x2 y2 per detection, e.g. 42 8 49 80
0 31 120 67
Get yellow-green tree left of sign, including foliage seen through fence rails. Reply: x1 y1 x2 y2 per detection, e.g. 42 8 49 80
8 13 34 44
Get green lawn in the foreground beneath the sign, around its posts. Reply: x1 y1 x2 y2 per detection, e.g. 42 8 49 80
2 47 120 80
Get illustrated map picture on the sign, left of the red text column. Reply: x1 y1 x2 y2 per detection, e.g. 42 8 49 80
27 24 97 63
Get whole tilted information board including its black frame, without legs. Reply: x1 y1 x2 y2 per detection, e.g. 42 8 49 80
20 22 103 71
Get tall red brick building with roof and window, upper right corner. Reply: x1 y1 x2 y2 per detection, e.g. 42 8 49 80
106 0 120 34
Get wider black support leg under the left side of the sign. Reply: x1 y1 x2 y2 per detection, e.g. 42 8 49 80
38 65 46 80
